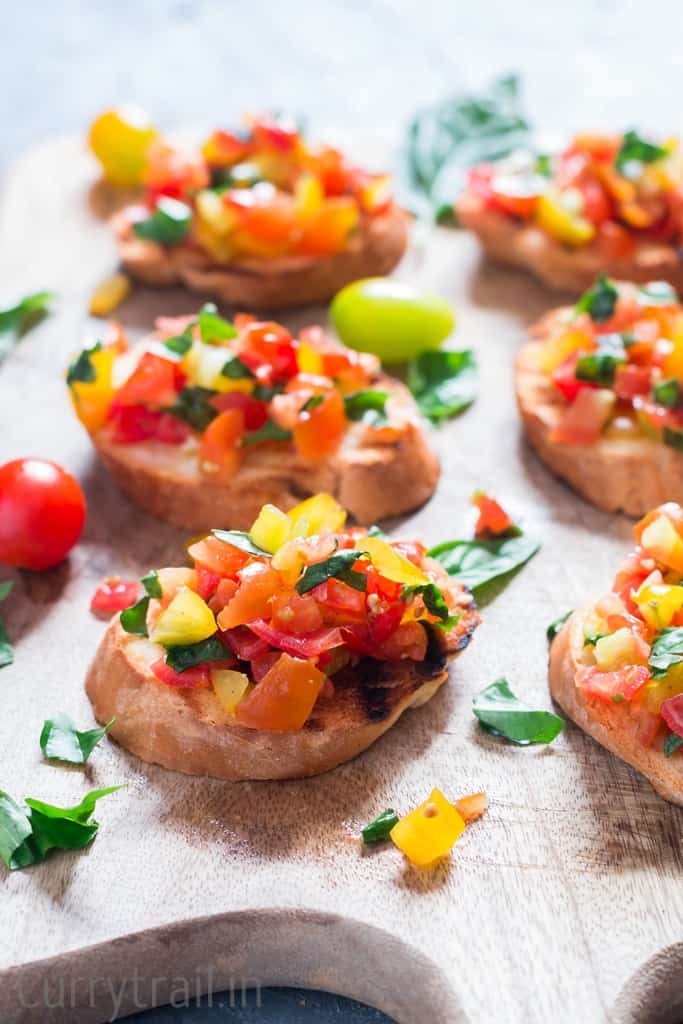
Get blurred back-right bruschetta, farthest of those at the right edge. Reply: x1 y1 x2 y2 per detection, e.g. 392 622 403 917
456 131 683 293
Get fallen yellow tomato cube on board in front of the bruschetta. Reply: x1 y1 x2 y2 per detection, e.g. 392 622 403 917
389 790 465 867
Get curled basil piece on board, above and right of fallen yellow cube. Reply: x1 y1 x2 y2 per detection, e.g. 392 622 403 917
472 679 564 746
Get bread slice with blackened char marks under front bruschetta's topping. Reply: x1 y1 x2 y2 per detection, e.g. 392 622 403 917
85 605 479 780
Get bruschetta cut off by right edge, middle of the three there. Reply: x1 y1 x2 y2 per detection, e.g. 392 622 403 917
516 278 683 516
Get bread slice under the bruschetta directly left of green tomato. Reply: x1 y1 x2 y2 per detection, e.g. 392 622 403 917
92 375 440 531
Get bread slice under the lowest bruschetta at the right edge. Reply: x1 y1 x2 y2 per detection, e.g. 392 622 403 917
549 607 683 806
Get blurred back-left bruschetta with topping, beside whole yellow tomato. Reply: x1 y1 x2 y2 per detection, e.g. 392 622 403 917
96 117 408 309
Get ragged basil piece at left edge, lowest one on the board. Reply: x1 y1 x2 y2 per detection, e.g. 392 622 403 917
0 785 122 870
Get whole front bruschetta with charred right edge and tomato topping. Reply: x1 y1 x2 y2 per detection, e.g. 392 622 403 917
86 495 479 779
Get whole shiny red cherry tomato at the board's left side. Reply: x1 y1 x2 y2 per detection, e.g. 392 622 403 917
0 459 85 569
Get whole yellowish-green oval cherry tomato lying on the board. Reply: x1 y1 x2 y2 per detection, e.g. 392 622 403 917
330 278 456 362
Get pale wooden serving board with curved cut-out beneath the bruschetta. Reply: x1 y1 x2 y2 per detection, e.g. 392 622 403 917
0 140 683 1024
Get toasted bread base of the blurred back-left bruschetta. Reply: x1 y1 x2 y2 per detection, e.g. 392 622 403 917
112 204 409 309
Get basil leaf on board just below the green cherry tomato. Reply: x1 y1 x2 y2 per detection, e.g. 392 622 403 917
408 349 477 424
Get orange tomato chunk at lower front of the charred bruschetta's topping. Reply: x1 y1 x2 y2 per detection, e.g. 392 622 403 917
236 654 327 732
